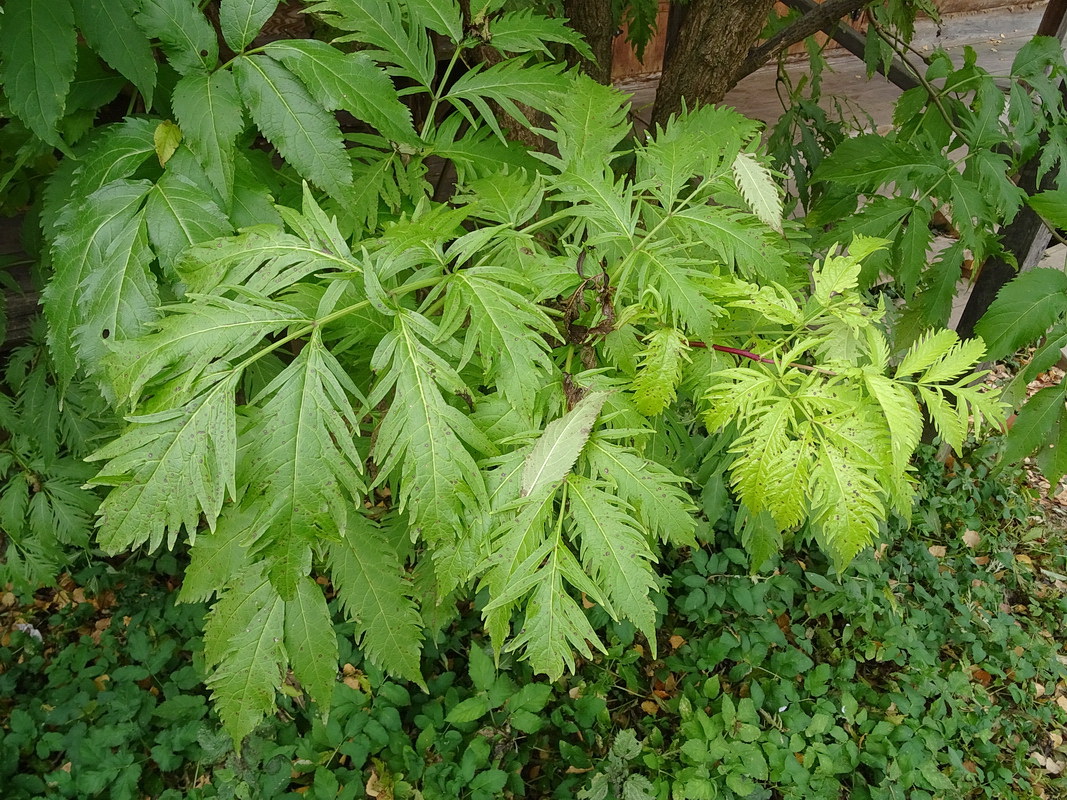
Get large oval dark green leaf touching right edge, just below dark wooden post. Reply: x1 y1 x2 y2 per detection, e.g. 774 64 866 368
974 268 1067 359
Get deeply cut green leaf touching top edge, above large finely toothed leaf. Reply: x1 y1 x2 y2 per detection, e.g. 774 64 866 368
307 0 436 89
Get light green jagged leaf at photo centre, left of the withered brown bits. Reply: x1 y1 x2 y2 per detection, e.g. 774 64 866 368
441 267 558 414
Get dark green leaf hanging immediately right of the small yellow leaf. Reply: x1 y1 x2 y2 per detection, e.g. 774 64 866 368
171 69 244 201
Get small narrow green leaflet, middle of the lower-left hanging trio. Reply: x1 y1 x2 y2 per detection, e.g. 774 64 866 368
284 577 337 718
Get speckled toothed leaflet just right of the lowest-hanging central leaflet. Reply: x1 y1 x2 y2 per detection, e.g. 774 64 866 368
567 475 657 658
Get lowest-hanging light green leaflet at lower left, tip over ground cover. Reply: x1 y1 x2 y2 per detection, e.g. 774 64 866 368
204 570 283 747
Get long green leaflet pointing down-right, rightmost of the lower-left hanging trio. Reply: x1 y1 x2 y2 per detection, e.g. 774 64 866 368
329 511 423 684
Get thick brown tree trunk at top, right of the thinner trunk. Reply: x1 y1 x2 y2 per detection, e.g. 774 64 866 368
652 0 775 125
